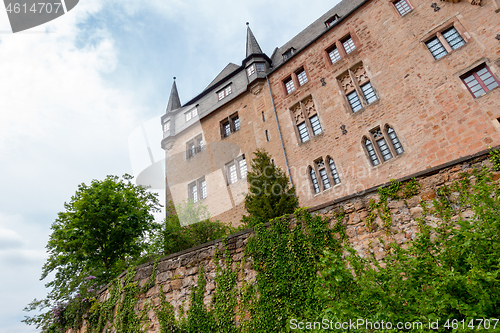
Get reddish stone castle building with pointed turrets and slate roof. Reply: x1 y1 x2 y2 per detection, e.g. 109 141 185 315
161 0 500 225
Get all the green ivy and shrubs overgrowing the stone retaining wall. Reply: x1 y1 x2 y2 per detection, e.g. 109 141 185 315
25 154 500 332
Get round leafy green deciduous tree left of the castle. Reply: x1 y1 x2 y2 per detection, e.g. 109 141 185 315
24 175 160 331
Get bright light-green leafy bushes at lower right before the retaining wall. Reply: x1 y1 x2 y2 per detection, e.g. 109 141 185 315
318 165 500 331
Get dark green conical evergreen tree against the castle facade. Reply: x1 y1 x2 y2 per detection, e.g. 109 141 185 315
243 149 298 226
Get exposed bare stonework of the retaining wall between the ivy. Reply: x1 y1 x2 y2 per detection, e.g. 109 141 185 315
71 153 500 332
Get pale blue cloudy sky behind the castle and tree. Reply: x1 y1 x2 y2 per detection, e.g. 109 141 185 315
0 0 338 333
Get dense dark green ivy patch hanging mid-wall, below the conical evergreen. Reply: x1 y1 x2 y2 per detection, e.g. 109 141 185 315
241 210 342 332
